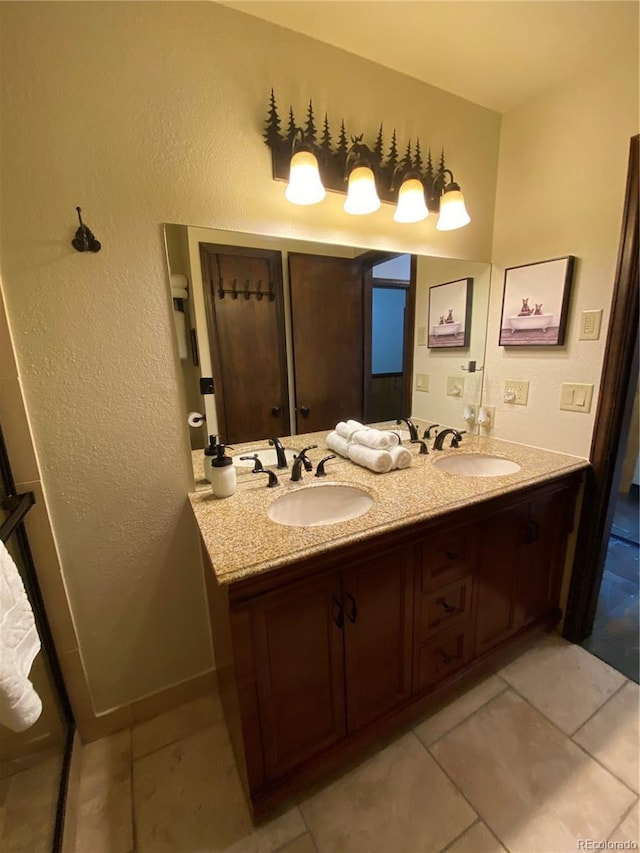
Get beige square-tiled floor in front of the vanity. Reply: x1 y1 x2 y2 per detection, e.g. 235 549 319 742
71 636 640 853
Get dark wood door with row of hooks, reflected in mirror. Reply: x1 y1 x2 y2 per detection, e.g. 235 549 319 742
200 243 291 444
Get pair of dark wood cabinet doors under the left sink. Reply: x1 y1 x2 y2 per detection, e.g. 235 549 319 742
234 547 413 781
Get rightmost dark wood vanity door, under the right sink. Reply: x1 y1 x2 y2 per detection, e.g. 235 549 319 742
515 492 569 628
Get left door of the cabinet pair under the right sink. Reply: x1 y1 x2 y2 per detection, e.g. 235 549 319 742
474 502 529 655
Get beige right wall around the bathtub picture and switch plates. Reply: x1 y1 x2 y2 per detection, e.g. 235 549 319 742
483 48 639 457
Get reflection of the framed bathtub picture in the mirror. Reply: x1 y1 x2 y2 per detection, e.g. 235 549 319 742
428 278 473 349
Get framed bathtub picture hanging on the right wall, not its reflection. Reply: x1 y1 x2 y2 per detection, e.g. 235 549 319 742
498 255 575 347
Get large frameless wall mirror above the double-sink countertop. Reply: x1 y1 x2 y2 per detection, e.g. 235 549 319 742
165 224 491 450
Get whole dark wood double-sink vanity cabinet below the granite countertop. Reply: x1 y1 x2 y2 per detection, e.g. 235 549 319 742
207 475 579 818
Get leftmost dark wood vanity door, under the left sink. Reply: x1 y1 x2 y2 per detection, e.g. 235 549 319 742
252 573 346 779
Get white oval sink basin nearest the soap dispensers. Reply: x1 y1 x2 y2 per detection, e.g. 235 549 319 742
267 483 373 527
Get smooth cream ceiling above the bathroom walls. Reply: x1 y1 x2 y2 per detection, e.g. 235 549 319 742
224 0 640 113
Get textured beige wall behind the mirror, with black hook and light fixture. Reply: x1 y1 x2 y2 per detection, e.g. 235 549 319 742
0 2 500 712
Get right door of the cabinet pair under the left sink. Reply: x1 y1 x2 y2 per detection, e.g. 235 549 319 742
343 547 413 732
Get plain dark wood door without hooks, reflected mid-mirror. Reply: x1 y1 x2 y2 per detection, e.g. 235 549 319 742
289 253 364 433
